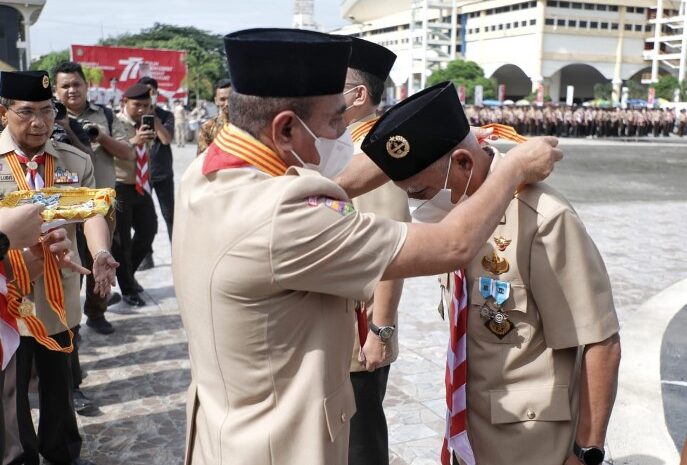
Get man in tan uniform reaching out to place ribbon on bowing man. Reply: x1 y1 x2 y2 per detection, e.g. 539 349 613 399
172 29 561 465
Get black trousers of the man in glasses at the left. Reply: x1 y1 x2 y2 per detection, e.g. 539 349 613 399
2 331 81 465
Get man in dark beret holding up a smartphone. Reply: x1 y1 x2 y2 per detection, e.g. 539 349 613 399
112 84 164 307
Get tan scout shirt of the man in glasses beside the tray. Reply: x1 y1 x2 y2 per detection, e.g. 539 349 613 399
0 130 95 335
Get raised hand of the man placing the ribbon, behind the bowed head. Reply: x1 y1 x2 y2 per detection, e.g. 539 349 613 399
497 137 563 184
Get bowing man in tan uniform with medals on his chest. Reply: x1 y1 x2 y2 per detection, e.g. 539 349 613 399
362 83 620 465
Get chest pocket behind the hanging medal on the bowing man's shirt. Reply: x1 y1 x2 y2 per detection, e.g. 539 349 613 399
468 279 534 344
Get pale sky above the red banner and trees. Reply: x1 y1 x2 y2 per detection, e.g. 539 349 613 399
31 0 345 58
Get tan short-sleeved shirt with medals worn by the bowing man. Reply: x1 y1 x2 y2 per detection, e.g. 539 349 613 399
444 150 618 465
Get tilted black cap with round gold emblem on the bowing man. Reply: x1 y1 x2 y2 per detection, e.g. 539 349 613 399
362 82 470 181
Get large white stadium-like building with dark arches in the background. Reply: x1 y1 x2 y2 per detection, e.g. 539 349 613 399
334 0 685 101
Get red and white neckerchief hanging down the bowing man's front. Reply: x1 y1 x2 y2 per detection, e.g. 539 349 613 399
441 270 475 465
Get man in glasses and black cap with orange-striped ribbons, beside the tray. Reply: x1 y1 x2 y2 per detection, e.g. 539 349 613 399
0 71 118 464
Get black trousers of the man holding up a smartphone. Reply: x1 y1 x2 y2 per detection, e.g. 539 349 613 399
112 182 157 294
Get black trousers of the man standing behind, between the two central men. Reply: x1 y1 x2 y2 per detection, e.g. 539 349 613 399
348 366 390 465
